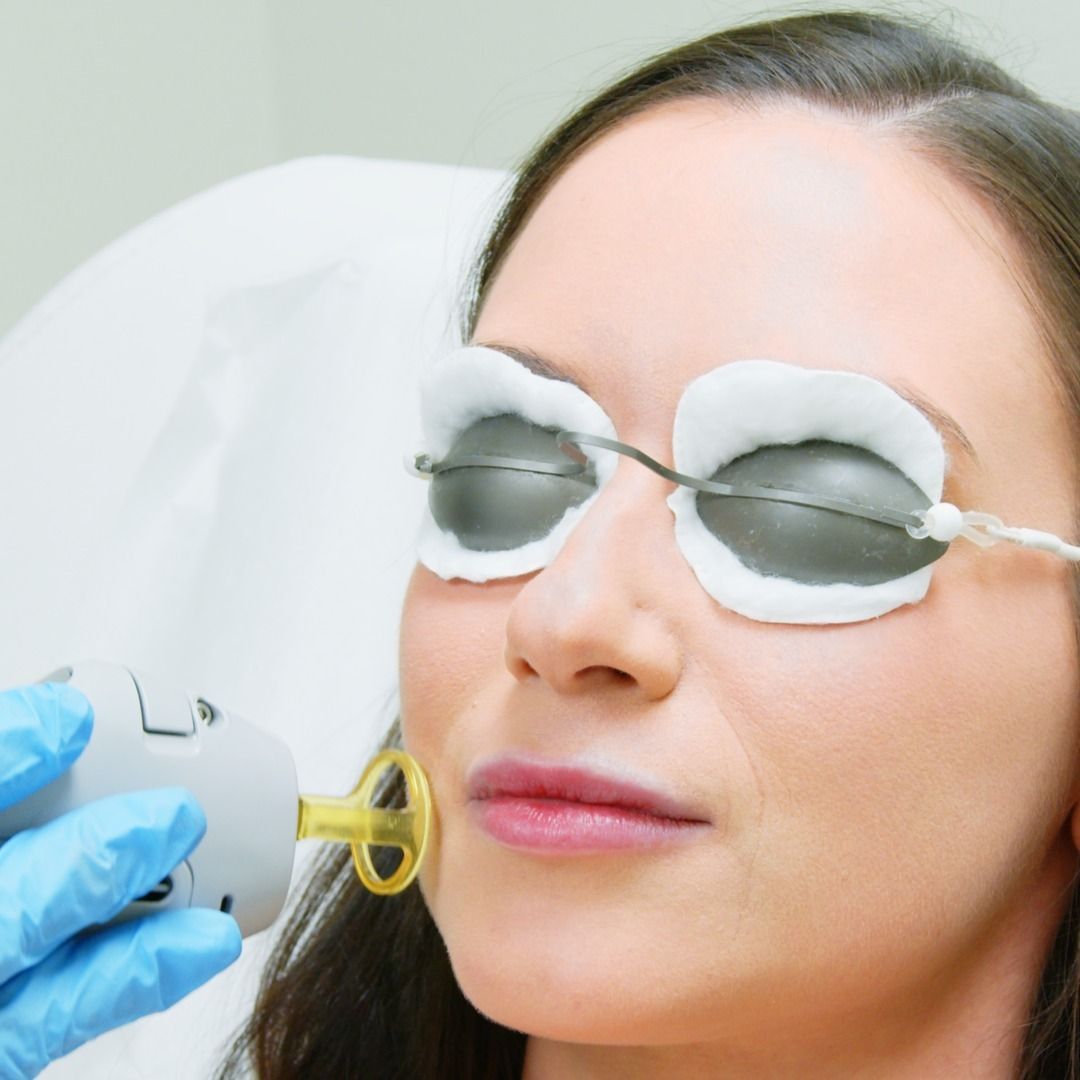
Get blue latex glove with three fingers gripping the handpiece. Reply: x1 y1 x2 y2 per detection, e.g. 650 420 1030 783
0 683 241 1080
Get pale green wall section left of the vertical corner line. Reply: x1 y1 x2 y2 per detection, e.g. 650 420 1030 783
0 0 282 334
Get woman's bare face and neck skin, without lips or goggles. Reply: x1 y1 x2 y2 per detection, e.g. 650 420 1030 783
400 100 1080 1080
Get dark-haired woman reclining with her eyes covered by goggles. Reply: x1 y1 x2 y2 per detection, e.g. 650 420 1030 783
222 14 1080 1080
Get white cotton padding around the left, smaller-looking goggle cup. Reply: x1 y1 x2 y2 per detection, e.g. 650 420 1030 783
418 346 619 582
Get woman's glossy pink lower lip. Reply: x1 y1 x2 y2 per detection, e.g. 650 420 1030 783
470 795 706 854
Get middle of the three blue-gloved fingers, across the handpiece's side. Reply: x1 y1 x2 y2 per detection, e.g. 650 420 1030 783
0 787 206 983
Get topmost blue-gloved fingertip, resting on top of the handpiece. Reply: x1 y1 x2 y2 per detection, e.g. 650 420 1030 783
0 683 94 810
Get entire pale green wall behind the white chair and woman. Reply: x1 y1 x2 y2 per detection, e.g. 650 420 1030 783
0 0 1080 334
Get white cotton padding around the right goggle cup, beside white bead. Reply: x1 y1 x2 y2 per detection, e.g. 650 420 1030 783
667 360 946 623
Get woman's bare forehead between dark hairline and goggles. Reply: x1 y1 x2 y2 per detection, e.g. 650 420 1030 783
474 100 1047 477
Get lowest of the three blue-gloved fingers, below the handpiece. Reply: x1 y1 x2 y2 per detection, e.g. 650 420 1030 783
0 907 241 1078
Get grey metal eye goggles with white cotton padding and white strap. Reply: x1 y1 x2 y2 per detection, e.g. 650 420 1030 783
406 346 1080 623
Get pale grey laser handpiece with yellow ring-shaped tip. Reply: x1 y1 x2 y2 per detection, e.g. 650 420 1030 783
0 660 433 936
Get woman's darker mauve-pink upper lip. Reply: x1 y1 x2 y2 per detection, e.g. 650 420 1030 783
467 754 708 822
